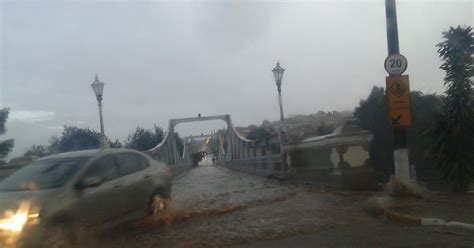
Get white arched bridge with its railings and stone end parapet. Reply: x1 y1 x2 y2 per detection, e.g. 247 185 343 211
146 115 374 189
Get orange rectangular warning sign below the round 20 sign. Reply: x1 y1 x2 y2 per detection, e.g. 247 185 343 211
386 75 411 127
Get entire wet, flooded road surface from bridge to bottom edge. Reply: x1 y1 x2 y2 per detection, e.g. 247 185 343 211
93 165 474 247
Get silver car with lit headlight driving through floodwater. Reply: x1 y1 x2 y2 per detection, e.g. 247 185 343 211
0 149 171 246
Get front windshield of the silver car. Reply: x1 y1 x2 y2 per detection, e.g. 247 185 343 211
0 158 87 191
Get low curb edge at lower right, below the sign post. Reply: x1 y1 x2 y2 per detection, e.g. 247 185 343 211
383 209 474 231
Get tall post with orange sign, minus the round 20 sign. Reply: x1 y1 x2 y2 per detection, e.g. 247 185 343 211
384 0 412 184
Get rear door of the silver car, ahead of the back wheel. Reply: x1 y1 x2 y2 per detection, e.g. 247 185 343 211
117 152 154 214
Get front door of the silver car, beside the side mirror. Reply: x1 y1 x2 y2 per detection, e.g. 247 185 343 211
72 154 122 225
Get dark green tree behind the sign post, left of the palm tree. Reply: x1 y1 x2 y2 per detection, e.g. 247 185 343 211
354 86 443 182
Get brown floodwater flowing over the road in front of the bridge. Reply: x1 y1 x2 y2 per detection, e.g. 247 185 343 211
99 165 370 247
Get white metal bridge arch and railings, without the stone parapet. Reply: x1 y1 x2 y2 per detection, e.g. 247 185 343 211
146 115 283 176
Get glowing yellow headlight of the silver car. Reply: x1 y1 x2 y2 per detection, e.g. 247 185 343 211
0 203 39 232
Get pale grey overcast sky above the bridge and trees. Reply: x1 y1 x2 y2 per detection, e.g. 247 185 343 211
0 0 474 156
